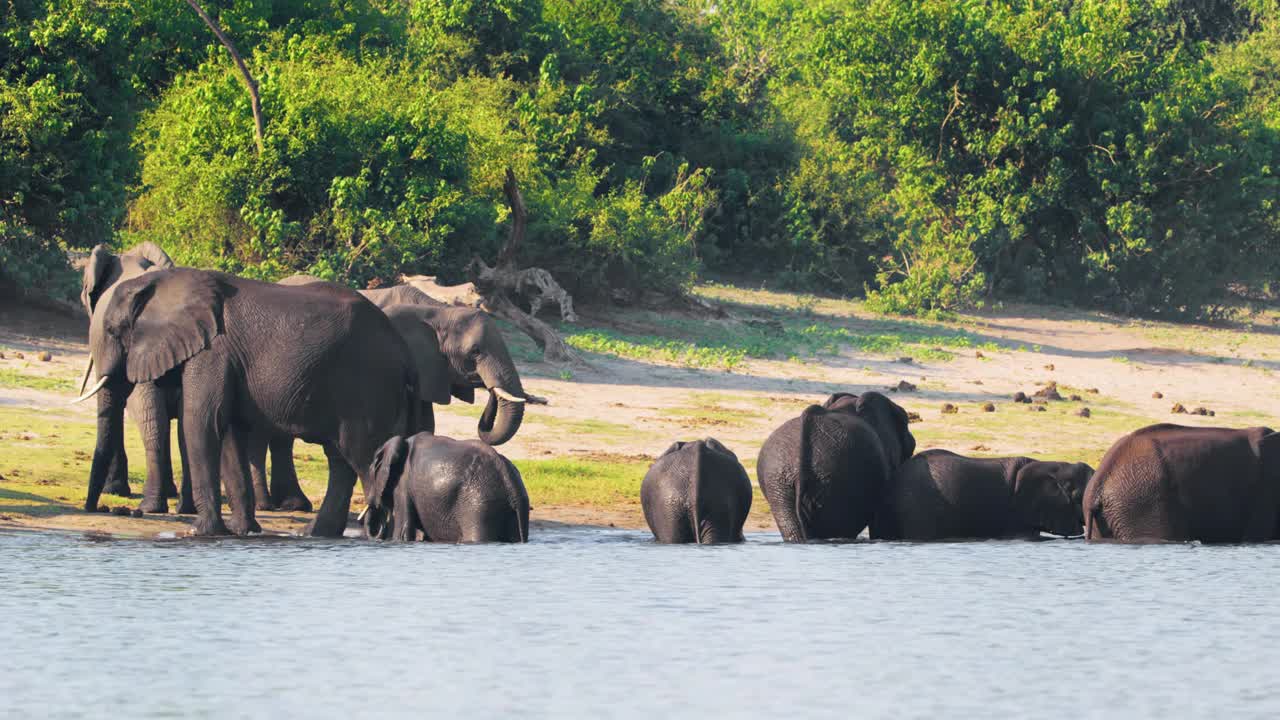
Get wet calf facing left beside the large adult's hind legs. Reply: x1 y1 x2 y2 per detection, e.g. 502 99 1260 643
365 433 529 542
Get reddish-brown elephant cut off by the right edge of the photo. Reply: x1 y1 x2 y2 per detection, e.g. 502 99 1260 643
1083 424 1280 542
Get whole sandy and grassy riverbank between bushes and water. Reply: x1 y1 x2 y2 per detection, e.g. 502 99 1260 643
0 284 1280 537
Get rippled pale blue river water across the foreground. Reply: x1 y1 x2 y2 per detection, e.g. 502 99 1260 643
0 528 1280 719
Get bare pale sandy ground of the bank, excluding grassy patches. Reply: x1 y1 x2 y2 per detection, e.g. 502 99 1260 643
0 288 1280 534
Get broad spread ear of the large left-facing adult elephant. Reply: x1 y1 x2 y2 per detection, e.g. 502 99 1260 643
104 269 223 383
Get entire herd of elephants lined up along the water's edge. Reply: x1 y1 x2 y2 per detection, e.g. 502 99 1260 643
79 243 1280 543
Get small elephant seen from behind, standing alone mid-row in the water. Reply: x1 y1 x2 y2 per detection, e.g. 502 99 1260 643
640 438 751 543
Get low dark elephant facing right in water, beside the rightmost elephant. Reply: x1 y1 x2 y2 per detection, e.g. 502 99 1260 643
872 450 1093 541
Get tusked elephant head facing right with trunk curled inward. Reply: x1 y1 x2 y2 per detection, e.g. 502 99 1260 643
422 306 529 445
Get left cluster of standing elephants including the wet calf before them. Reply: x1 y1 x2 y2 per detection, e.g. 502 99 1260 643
79 243 538 541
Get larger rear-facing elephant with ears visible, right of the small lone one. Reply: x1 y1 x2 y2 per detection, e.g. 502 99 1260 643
755 392 915 542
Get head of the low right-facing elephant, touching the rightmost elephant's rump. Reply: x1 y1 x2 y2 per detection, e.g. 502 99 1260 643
1014 460 1093 537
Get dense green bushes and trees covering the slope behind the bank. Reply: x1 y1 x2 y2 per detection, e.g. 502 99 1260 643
0 0 1280 316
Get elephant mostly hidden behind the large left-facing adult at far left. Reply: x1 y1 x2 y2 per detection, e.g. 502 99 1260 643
81 242 186 512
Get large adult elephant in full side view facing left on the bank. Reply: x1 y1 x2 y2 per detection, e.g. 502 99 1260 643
82 269 417 537
